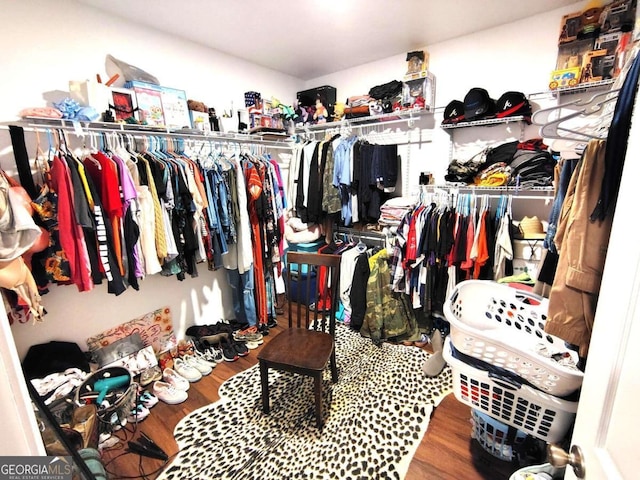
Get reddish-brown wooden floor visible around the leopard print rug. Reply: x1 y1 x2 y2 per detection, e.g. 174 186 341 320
103 320 516 480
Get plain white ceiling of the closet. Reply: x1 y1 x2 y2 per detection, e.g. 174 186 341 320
77 0 582 80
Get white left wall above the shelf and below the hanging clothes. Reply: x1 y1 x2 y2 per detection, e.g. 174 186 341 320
0 0 302 358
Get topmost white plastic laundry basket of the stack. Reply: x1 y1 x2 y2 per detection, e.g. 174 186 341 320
444 280 584 397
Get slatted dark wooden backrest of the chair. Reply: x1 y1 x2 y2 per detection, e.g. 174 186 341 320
287 252 340 336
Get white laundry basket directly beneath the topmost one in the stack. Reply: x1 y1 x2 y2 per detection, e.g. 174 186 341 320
442 337 578 442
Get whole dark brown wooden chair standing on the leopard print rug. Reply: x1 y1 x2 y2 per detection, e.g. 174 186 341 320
258 252 340 428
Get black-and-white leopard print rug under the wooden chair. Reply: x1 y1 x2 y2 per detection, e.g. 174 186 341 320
158 325 451 480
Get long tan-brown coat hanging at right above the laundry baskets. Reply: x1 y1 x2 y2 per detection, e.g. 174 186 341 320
545 140 612 357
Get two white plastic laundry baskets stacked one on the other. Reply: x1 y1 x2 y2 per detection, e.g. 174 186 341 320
443 280 583 458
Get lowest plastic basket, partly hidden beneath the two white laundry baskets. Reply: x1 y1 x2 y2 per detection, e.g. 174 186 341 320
471 409 527 462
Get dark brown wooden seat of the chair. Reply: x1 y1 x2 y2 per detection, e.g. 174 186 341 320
258 328 333 371
